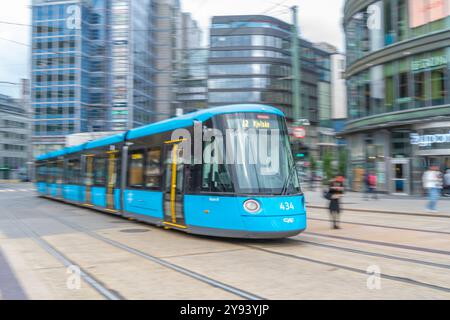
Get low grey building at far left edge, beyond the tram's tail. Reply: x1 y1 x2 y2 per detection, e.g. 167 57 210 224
0 94 30 180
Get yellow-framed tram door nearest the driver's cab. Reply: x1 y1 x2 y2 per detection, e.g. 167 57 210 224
164 140 186 228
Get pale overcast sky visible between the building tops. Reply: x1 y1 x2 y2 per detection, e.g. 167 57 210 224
0 0 345 98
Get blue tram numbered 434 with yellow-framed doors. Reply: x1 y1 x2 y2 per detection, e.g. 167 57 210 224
35 105 306 239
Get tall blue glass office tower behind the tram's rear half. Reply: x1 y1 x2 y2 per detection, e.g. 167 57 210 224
31 0 153 155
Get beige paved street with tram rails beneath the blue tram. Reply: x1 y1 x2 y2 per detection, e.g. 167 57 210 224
0 184 450 300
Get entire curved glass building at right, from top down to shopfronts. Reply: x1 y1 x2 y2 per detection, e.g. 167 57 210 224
344 0 450 194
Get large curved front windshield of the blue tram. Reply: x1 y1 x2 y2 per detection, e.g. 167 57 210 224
202 113 301 195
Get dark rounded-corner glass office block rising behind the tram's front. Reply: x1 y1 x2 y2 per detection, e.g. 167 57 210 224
208 15 338 160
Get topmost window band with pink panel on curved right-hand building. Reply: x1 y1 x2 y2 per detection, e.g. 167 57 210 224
344 0 450 65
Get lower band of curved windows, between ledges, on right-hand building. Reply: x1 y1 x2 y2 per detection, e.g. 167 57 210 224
347 48 450 120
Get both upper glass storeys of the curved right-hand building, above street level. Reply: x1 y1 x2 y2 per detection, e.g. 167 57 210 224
344 0 450 124
